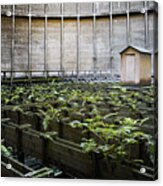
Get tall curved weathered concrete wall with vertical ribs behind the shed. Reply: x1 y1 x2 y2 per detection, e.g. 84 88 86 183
1 1 157 77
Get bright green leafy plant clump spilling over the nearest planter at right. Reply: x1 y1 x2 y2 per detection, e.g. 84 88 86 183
81 118 153 161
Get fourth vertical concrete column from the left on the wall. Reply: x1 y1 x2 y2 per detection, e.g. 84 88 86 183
60 3 64 75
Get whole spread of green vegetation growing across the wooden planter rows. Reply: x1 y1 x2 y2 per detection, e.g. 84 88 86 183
1 82 154 166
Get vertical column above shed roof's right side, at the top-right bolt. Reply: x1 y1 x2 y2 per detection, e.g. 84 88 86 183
144 1 149 48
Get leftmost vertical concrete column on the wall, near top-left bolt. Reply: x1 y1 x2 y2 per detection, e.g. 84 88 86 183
10 5 15 80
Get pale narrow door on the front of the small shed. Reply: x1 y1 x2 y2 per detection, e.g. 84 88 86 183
126 54 136 82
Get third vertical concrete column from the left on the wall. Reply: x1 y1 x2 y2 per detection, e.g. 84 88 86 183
44 5 48 77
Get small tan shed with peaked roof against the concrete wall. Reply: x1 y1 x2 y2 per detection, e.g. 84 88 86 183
120 45 151 84
